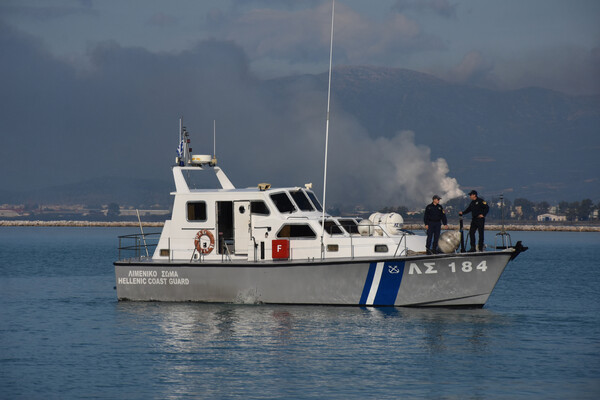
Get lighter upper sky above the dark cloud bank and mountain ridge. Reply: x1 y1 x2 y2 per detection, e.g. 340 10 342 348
0 0 600 94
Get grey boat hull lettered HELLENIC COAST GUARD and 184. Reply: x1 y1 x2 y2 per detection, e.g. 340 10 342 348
115 249 513 307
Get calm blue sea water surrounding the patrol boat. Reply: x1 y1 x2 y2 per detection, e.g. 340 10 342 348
0 227 600 399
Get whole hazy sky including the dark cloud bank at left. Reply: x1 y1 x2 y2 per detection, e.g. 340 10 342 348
0 0 600 206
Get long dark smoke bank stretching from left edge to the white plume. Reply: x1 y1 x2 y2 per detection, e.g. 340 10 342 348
0 20 458 206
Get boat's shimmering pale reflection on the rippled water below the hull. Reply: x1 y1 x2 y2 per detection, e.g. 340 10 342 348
116 302 507 397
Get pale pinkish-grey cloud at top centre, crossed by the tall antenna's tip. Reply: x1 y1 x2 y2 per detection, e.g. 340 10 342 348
207 2 444 73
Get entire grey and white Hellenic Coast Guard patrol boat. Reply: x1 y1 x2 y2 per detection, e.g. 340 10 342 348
114 123 523 307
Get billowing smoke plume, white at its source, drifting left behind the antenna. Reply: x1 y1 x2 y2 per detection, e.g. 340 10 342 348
223 86 464 208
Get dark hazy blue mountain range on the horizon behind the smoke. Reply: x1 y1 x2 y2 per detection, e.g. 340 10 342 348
0 67 600 206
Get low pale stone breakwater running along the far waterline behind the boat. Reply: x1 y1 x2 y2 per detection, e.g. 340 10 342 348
0 220 600 232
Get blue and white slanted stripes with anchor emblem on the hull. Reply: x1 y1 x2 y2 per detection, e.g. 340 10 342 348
359 261 404 306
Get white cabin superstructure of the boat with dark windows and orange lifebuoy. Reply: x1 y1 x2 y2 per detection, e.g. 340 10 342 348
152 163 425 262
